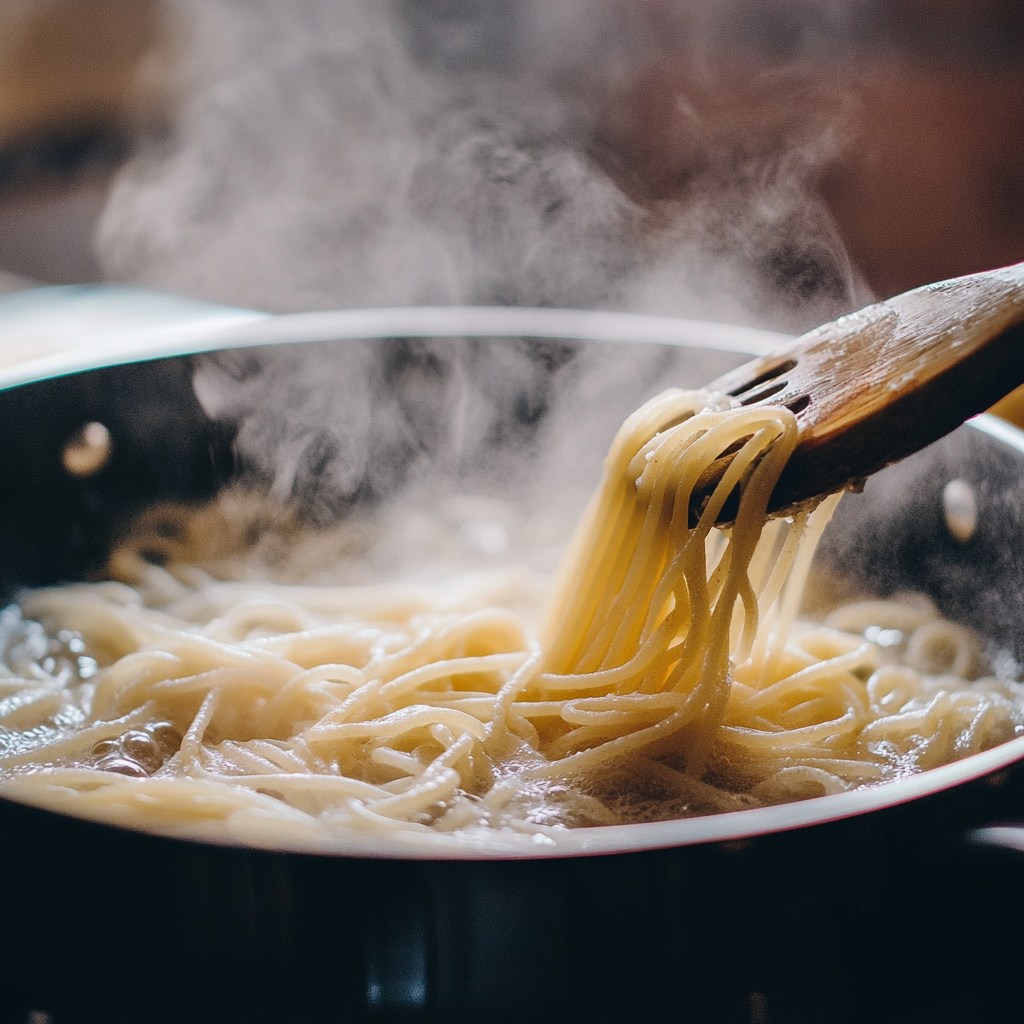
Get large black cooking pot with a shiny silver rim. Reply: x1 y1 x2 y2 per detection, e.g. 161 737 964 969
0 309 1024 1024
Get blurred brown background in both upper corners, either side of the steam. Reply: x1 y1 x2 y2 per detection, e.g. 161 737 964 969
0 0 1024 296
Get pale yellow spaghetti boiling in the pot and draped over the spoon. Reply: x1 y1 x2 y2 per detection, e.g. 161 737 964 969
0 390 1022 846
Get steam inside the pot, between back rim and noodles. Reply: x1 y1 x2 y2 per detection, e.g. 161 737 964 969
188 338 742 582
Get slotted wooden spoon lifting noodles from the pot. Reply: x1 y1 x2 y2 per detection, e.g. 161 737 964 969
693 263 1024 517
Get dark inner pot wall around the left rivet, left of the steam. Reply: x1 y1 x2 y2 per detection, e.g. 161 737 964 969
0 358 231 601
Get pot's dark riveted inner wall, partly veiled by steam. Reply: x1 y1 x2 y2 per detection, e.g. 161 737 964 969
0 316 1024 857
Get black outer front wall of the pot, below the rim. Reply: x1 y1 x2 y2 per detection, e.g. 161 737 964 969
6 765 1024 1024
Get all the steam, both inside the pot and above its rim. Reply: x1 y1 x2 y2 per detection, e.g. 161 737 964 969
97 0 866 547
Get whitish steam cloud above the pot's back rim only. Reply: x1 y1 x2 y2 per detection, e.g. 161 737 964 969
97 0 864 330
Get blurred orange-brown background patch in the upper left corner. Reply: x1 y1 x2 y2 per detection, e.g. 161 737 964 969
0 0 161 289
